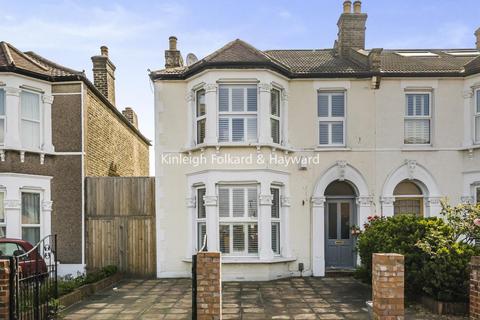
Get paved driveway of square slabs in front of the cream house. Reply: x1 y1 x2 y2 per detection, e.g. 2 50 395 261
65 278 466 319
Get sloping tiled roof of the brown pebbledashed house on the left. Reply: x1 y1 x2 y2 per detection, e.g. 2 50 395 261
0 41 151 145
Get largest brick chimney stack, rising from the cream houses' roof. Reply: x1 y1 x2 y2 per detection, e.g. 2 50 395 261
336 0 367 57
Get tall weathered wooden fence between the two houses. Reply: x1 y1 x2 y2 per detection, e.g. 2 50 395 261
85 177 156 277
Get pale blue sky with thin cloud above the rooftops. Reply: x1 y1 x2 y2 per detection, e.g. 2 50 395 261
0 0 480 174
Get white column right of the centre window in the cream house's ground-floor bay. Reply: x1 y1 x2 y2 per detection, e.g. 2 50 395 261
258 190 273 260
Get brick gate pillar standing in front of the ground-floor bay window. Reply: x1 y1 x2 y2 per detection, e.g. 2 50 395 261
197 252 222 320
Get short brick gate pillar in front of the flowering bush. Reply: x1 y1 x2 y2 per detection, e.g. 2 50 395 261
372 253 405 320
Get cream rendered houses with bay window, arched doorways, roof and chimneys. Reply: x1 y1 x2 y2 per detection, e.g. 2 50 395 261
150 0 480 280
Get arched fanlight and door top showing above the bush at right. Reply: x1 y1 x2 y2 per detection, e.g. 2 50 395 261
393 181 423 216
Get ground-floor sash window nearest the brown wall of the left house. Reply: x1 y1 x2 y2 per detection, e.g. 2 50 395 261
22 192 40 245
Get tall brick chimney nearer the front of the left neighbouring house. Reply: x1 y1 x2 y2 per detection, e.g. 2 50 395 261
92 46 115 105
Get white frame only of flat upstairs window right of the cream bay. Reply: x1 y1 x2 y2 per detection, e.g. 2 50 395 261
316 90 347 148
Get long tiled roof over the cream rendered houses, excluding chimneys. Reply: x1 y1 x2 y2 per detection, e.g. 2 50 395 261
150 39 480 80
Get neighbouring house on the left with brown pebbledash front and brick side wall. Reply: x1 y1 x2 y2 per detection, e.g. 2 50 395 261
0 42 150 273
